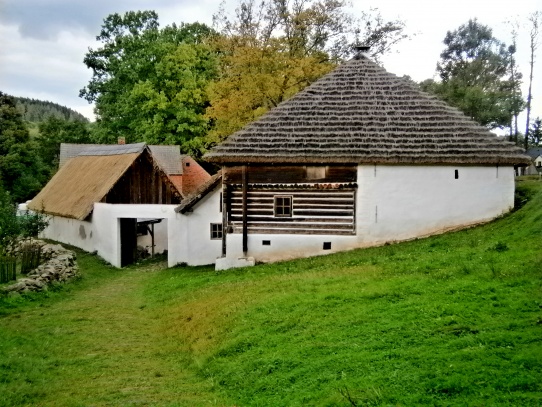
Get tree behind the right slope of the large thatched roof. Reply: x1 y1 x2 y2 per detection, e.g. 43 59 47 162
421 20 522 129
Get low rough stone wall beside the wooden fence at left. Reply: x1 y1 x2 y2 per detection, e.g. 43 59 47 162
1 240 79 293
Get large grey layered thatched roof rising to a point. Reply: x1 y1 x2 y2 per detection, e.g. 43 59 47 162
204 56 529 165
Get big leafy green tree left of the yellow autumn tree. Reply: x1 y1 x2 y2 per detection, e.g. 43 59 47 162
80 11 215 148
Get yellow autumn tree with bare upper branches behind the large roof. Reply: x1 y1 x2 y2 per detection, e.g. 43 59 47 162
207 0 406 142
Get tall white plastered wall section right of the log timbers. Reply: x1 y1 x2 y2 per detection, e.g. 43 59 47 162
356 166 515 244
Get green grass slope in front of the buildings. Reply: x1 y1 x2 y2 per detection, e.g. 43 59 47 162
0 179 542 406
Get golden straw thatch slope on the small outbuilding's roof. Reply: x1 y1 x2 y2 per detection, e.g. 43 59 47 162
28 153 141 220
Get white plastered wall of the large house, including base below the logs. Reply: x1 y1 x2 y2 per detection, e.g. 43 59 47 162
226 165 514 262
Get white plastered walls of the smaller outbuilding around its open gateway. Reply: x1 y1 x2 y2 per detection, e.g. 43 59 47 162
42 196 222 267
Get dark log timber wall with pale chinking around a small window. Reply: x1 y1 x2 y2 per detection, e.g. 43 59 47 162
224 165 357 235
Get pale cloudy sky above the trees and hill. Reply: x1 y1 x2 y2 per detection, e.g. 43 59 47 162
0 0 542 126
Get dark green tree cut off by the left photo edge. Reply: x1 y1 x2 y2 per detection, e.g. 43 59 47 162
0 92 46 202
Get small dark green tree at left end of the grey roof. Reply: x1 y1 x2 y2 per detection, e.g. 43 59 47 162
36 116 93 174
